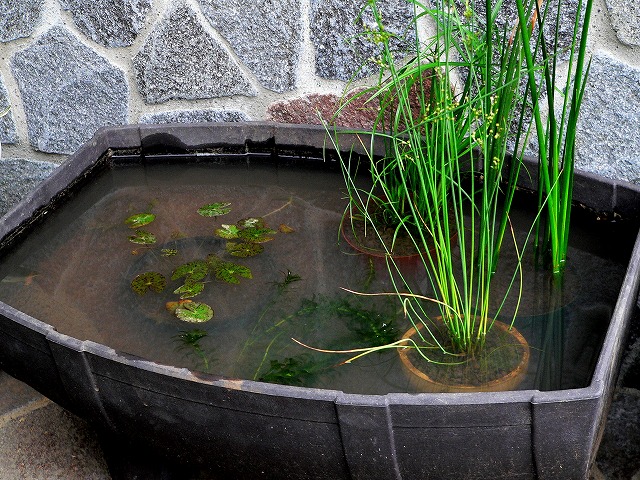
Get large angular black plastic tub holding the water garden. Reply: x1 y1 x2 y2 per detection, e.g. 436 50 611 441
0 123 640 480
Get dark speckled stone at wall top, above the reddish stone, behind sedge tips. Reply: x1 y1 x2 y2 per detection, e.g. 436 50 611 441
310 0 415 81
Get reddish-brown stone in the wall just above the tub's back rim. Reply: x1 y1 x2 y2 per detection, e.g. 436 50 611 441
267 93 378 129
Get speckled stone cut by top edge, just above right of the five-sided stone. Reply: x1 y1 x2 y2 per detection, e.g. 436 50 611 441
60 0 151 47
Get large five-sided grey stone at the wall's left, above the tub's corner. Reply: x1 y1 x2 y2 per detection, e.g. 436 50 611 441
11 26 128 153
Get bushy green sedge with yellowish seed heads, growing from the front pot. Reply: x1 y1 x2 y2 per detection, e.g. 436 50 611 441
322 0 588 368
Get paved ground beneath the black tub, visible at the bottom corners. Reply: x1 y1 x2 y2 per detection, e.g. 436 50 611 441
0 371 640 480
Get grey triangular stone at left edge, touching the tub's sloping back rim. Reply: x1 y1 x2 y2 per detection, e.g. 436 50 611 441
0 158 57 216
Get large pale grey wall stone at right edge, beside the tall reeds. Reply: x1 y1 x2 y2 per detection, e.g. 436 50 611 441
576 54 640 183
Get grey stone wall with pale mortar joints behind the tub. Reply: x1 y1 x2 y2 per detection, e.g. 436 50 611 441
0 0 640 183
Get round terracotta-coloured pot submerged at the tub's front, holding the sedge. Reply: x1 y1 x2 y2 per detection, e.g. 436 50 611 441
398 321 529 393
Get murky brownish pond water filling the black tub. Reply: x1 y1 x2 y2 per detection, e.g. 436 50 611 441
0 160 629 394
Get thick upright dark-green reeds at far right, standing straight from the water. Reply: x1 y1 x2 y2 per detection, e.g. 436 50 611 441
516 0 593 279
